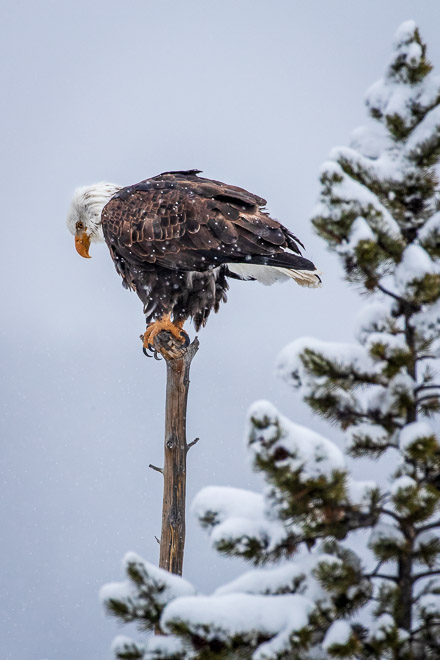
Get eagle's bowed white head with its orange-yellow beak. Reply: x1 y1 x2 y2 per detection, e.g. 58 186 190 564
67 182 121 258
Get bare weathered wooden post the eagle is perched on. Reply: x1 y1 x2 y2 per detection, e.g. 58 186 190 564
153 332 199 575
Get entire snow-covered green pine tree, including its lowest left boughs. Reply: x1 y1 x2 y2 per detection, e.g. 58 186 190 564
102 22 440 660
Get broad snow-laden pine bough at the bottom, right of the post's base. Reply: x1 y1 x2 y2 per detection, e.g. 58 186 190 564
156 542 371 660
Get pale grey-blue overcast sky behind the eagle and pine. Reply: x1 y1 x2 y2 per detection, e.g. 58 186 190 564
0 0 440 660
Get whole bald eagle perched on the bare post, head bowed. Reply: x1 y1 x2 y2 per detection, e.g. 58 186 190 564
67 170 321 356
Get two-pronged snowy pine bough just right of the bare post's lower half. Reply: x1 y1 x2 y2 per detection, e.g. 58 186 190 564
192 401 378 564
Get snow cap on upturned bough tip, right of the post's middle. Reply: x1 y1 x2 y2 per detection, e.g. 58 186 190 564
248 401 345 482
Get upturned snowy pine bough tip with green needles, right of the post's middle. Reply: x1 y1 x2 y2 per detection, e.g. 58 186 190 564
247 401 378 538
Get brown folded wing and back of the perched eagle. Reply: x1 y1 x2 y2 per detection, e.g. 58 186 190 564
102 170 315 284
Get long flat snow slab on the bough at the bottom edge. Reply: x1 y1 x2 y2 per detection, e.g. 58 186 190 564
161 594 314 660
